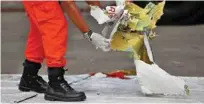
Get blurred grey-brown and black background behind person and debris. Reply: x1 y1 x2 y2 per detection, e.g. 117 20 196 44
1 1 204 76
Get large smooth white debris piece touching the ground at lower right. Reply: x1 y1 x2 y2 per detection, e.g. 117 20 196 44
134 60 189 95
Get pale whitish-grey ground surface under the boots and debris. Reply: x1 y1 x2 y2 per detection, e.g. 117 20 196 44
1 73 204 104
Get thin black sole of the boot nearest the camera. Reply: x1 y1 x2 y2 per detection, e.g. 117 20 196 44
44 95 86 102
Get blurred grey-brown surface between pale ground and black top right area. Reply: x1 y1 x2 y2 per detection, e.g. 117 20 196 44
1 13 204 76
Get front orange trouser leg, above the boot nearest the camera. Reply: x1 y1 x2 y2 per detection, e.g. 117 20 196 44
23 1 68 67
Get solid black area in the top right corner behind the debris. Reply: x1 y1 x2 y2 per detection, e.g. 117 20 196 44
134 0 204 25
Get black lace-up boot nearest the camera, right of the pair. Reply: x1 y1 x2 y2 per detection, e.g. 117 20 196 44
44 68 86 101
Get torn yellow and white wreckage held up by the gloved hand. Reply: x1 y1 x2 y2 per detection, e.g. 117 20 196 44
91 0 189 95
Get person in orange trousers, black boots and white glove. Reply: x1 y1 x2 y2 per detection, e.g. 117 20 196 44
18 1 110 101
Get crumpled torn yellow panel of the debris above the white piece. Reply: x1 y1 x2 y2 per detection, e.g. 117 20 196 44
111 1 165 64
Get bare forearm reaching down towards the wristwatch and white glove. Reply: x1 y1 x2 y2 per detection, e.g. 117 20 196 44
61 0 89 33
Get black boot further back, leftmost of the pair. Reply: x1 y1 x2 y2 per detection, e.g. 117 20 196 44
18 60 48 93
